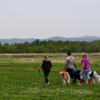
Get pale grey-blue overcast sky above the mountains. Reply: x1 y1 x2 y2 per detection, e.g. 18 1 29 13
0 0 100 39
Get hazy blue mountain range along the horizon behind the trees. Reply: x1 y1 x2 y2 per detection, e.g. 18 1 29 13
0 36 100 44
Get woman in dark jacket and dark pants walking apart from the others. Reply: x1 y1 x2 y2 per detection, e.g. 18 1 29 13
39 56 52 85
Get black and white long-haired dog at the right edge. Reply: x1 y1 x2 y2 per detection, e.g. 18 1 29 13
86 71 100 84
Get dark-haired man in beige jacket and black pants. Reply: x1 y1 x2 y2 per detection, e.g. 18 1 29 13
64 52 77 79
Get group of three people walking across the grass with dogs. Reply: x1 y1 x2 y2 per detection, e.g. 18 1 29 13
39 52 91 85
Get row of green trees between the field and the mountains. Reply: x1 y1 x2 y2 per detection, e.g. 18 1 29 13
0 39 100 53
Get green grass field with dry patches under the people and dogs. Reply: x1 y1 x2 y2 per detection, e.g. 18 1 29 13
0 53 100 100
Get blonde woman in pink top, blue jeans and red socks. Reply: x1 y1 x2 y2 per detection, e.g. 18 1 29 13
78 53 91 85
